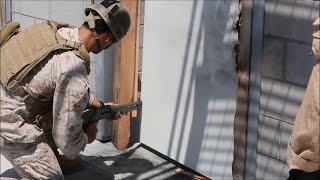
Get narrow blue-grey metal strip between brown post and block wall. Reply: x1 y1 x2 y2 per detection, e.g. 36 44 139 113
245 0 265 179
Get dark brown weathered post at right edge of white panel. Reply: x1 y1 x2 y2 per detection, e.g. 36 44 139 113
232 0 253 180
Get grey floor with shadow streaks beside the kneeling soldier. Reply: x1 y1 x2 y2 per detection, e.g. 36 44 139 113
0 141 200 180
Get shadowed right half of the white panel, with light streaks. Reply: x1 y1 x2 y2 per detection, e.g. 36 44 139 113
168 1 238 178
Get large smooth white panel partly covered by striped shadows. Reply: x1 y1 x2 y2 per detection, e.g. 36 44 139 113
141 0 239 179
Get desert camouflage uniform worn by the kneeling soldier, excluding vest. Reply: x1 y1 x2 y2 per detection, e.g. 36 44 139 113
0 28 93 179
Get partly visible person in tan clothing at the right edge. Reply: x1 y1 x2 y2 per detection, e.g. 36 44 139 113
287 18 320 180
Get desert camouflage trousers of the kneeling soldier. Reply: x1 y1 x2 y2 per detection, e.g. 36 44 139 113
0 85 64 179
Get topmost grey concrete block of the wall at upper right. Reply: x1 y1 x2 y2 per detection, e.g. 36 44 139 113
265 0 319 43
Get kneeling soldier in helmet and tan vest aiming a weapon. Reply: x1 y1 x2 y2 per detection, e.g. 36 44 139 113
0 0 130 179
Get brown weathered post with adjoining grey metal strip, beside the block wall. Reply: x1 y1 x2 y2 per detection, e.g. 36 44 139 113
232 0 265 179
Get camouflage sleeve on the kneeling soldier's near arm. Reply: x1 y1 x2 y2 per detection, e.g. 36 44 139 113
52 52 90 159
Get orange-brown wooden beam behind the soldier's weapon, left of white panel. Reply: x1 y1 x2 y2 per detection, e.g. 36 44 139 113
112 0 141 149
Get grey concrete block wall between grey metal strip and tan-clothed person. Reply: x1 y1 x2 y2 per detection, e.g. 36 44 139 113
256 0 320 179
